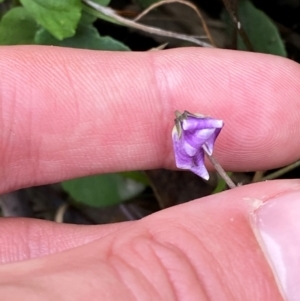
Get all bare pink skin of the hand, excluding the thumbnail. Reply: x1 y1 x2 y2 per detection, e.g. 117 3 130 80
0 46 300 301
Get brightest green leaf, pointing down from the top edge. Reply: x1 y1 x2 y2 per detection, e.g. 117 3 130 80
20 0 81 40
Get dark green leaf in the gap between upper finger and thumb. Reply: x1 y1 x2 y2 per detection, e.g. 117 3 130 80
62 174 145 207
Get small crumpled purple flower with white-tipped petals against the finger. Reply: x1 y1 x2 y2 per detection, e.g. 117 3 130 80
172 111 224 180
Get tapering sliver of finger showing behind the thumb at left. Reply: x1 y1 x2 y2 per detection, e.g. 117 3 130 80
0 218 130 263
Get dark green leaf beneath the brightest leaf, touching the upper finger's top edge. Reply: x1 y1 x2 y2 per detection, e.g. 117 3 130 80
35 24 130 50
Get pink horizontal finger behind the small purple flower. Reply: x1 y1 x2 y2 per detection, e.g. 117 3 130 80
0 46 300 192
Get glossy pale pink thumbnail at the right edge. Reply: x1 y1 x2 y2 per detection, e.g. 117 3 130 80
253 192 300 301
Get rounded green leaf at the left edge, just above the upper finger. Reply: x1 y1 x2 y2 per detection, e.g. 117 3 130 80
0 7 38 45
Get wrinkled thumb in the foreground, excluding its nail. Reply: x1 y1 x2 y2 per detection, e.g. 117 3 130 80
0 181 300 301
